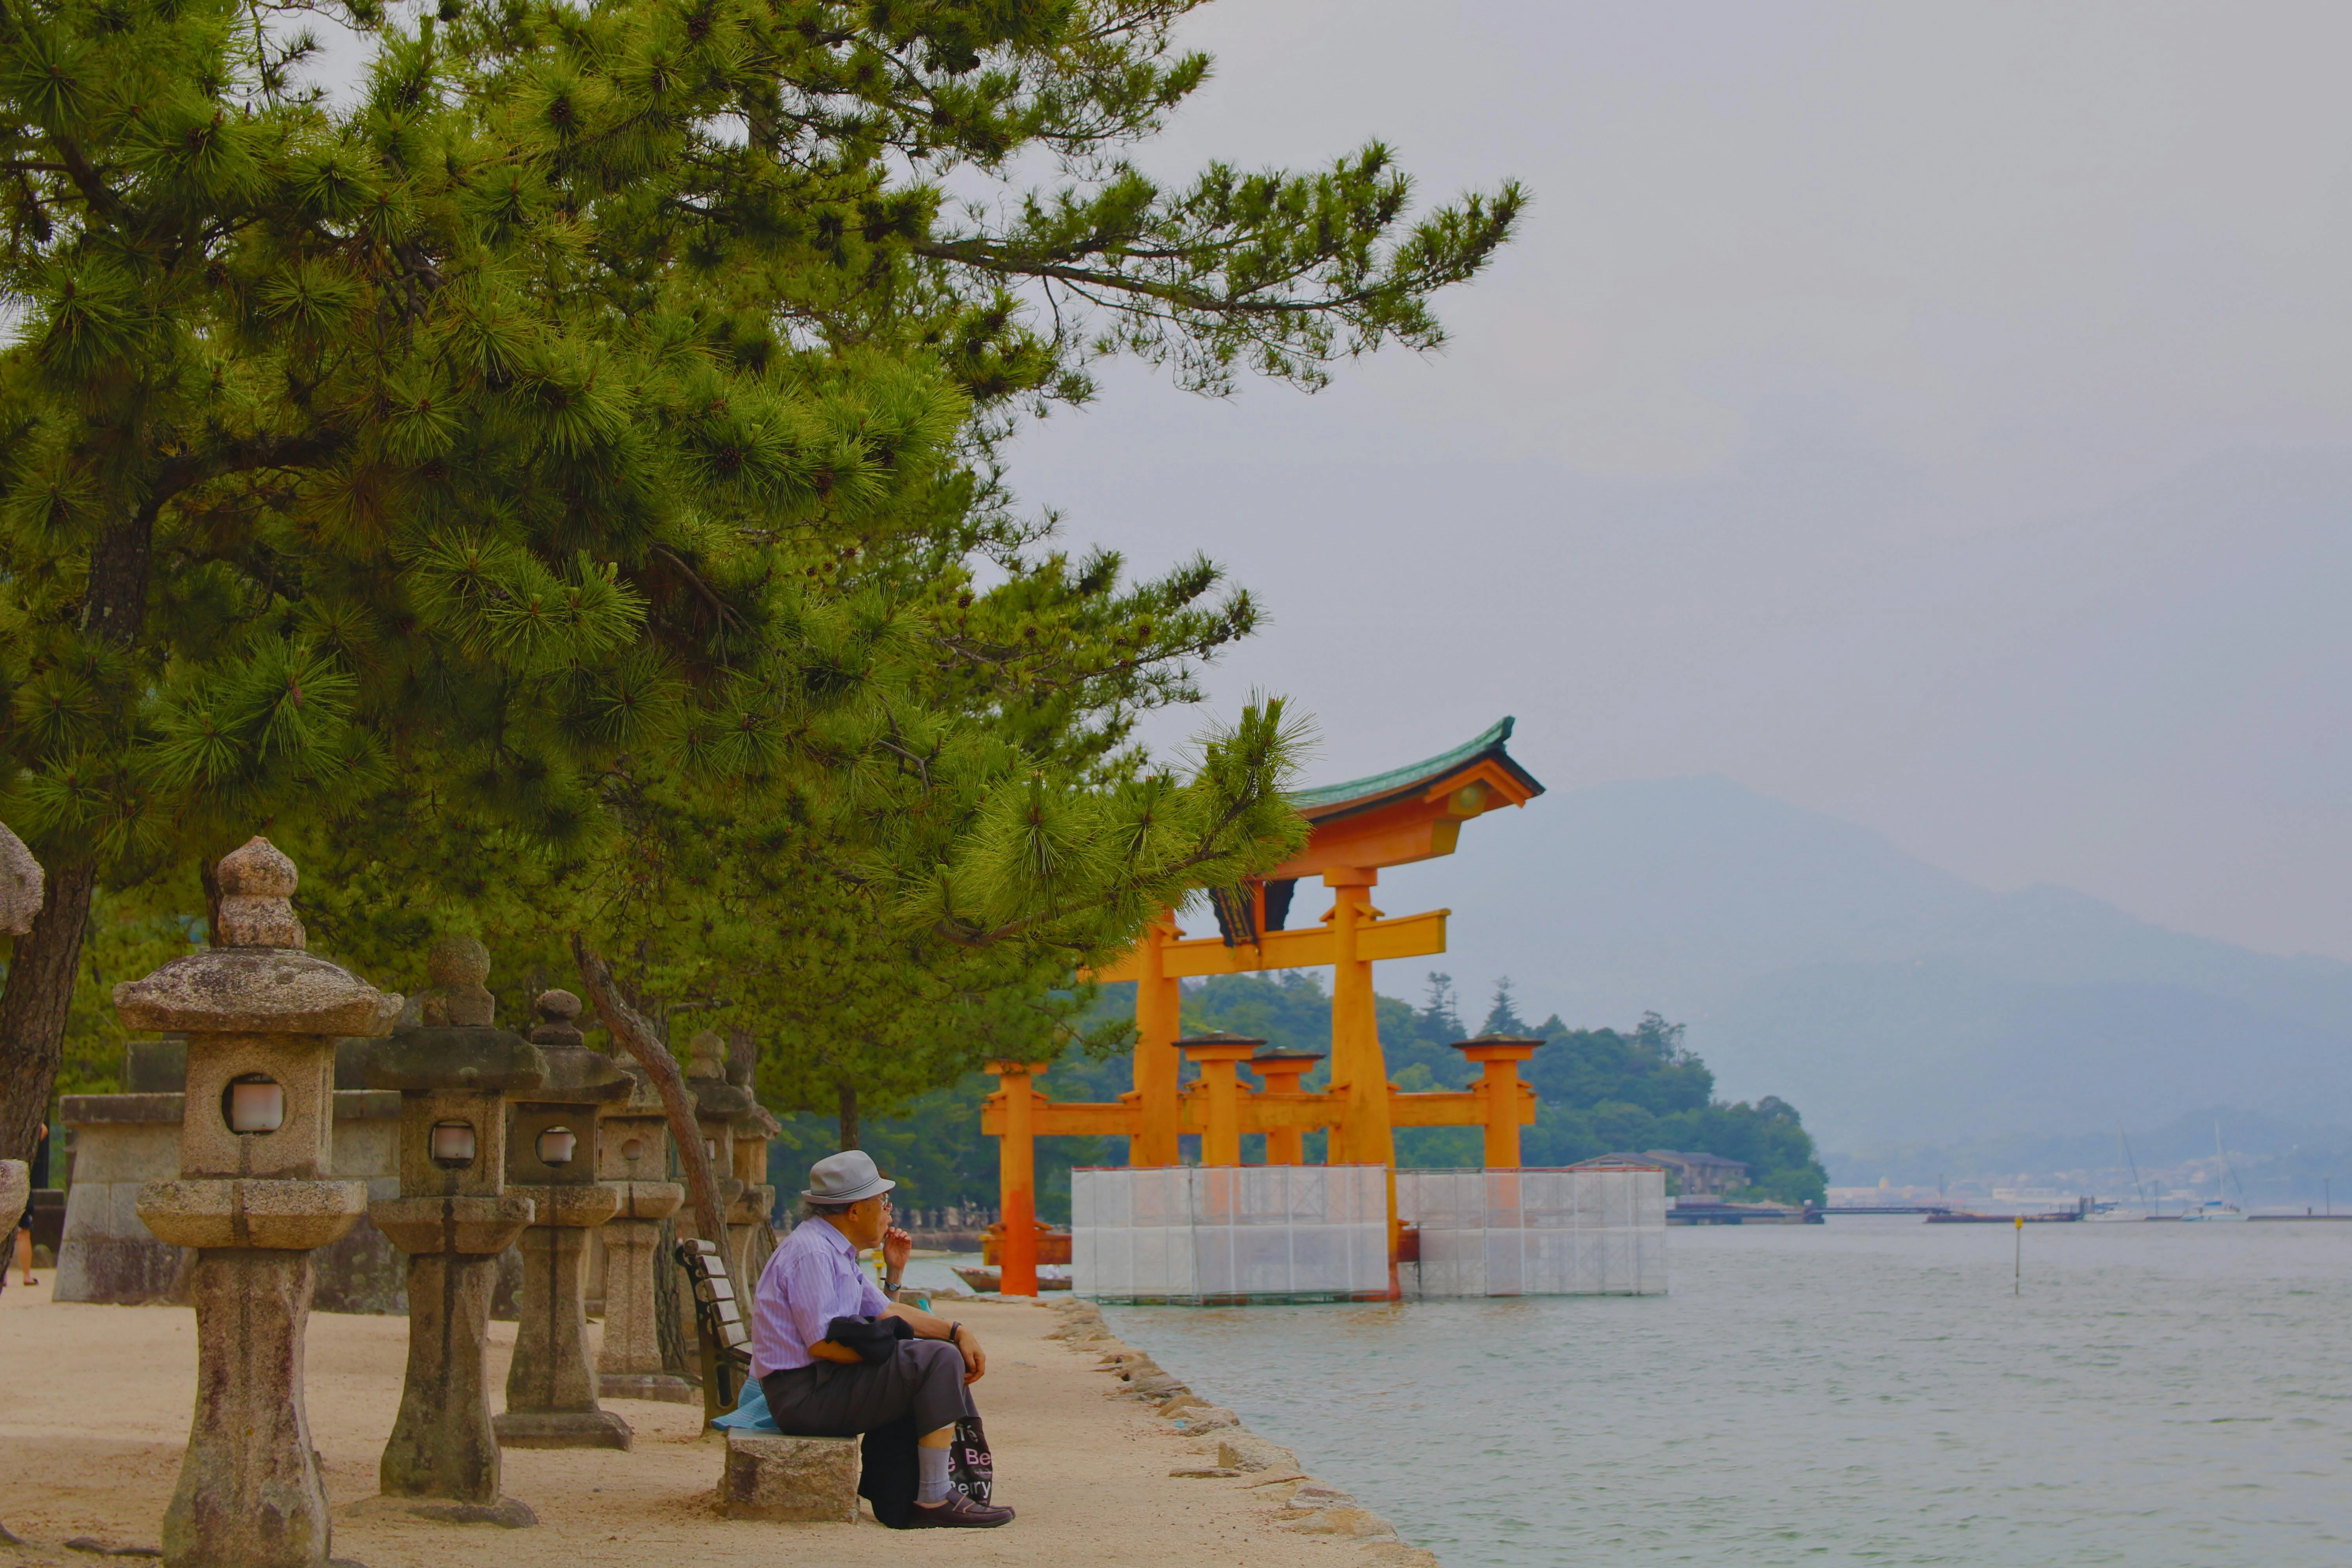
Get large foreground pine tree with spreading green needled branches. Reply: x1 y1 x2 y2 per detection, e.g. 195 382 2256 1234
0 0 1519 1152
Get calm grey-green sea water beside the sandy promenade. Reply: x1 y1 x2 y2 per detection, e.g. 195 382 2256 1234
1108 1218 2352 1568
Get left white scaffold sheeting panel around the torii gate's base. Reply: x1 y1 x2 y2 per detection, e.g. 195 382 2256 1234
1070 1166 1388 1305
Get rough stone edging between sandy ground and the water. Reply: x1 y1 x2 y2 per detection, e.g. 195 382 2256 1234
1044 1300 1437 1568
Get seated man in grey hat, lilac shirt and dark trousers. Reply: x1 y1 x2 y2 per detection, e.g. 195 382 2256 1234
750 1150 1014 1528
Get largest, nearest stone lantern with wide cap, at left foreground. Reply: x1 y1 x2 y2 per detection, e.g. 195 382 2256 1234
115 837 400 1568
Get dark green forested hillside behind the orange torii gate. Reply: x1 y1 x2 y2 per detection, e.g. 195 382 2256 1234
771 971 1828 1222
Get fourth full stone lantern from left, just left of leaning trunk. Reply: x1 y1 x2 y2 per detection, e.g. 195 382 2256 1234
595 1044 701 1403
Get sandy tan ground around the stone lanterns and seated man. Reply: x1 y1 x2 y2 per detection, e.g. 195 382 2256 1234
0 1274 1435 1568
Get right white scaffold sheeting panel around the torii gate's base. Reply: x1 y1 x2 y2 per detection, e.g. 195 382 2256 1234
1397 1171 1665 1295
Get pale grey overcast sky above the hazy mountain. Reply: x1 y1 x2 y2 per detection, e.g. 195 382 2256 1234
988 0 2352 973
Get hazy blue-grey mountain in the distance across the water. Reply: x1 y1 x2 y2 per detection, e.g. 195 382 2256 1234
1430 778 2352 1150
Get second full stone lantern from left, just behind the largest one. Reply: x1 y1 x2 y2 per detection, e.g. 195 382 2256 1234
365 936 548 1526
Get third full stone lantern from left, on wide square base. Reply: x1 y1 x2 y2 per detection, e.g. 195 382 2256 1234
496 992 633 1448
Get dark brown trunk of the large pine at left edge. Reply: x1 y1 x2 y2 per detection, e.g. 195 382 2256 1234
0 510 162 1159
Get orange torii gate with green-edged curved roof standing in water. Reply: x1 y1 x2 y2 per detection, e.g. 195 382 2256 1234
981 719 1543 1295
